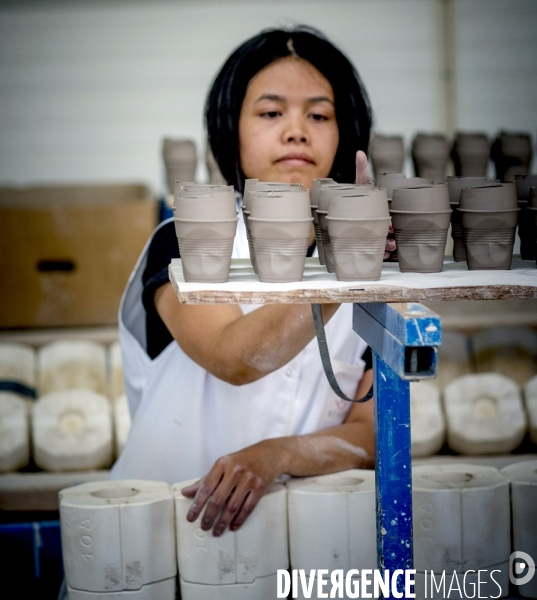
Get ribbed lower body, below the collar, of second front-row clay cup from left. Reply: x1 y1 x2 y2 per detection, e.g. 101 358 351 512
249 217 312 283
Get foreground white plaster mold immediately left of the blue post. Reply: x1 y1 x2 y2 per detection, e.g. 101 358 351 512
287 469 377 598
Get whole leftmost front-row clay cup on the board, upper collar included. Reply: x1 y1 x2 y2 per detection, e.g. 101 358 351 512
174 181 238 283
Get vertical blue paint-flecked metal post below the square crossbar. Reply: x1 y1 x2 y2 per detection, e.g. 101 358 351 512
373 352 413 592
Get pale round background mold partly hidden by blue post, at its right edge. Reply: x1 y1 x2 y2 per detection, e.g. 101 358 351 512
410 381 446 457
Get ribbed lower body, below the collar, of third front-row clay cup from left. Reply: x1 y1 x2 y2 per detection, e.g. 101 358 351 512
326 216 390 281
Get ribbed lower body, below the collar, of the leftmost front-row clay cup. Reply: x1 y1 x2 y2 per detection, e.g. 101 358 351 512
174 218 238 283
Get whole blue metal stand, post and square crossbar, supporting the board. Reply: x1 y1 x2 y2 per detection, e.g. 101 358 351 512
353 303 442 593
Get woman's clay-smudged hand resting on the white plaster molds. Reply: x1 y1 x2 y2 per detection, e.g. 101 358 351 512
181 439 284 537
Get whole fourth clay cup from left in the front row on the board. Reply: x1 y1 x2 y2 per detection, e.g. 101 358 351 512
390 183 451 273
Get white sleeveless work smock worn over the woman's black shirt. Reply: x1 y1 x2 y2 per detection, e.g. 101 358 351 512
111 204 367 484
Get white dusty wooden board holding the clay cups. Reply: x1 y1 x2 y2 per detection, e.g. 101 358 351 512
169 258 537 304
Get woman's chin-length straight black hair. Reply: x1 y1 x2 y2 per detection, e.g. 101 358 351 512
205 25 371 192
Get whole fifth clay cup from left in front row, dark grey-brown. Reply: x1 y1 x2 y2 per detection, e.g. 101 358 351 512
458 182 520 270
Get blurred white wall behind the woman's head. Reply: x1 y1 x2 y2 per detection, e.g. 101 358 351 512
0 0 537 191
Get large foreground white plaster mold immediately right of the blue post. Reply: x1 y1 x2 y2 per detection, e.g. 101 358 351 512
412 464 511 599
